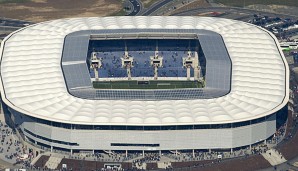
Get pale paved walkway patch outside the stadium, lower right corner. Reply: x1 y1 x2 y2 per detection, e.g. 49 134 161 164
262 149 287 166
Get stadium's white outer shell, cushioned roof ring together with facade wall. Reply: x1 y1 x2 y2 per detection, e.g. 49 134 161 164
0 16 289 150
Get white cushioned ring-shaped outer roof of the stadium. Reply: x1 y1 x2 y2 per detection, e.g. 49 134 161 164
1 16 289 125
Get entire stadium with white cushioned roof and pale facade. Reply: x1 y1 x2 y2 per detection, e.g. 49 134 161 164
1 16 289 153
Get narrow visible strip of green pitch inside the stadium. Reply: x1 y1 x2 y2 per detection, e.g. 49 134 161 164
93 80 203 89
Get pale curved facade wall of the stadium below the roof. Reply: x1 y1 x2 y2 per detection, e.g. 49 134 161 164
9 108 276 151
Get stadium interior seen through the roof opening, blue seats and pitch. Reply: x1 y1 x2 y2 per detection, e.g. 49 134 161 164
87 38 206 89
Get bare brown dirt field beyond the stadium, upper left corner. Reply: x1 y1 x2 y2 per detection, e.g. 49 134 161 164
0 0 122 22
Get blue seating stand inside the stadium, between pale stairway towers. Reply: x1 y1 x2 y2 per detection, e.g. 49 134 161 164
88 39 200 78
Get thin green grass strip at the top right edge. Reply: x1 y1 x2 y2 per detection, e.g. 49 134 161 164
214 0 298 7
